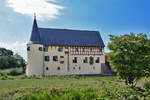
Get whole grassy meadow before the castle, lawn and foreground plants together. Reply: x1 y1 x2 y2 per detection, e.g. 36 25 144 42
0 69 150 100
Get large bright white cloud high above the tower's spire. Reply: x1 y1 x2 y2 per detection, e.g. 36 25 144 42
7 0 64 20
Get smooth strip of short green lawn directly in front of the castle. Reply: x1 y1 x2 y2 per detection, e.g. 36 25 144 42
0 76 117 94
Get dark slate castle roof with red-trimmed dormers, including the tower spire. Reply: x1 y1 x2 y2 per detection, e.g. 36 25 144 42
30 19 104 46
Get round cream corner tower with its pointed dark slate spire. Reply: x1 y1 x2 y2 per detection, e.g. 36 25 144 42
26 16 44 76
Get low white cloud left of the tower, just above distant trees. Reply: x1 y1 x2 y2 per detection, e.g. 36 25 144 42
0 41 27 59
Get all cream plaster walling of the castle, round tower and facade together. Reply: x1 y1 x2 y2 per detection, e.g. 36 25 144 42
26 44 105 76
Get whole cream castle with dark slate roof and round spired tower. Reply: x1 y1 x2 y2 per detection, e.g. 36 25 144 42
26 17 110 76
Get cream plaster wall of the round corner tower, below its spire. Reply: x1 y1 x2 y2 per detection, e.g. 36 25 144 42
26 44 44 76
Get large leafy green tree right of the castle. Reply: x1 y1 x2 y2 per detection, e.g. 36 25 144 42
108 33 150 86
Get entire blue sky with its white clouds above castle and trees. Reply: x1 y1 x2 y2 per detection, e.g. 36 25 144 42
0 0 150 58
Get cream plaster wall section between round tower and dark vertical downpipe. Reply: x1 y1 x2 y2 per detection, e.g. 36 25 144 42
44 46 68 76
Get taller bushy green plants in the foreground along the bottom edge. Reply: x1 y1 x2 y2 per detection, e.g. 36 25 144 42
3 87 150 100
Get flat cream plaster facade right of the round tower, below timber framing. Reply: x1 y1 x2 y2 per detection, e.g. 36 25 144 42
44 46 105 76
